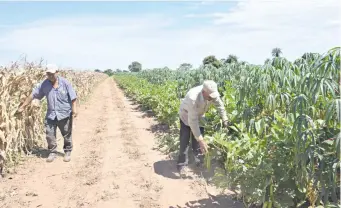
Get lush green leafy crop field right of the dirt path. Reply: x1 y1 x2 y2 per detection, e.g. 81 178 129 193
114 48 341 208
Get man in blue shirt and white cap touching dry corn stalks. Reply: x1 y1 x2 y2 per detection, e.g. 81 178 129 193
17 64 77 162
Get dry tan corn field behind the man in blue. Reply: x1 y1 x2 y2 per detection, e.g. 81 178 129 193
0 60 108 174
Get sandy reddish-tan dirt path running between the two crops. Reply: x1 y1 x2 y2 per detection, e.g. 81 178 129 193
0 78 241 208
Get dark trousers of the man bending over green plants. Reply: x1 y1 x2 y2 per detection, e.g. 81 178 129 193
177 119 204 169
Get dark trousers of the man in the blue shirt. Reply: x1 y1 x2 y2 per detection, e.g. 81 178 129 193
45 116 72 153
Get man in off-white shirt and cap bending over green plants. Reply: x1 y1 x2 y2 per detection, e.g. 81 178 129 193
177 80 229 175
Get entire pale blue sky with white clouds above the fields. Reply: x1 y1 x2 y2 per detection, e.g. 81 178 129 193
0 0 341 70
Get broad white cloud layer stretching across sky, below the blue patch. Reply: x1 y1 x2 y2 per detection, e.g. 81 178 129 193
0 0 341 69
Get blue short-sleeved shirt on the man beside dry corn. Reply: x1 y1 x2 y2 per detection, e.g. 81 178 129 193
32 76 77 120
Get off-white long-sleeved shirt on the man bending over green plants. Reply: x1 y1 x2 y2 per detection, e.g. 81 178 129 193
179 85 227 139
